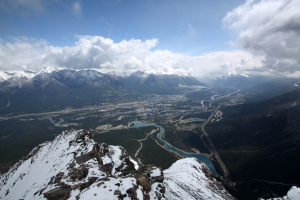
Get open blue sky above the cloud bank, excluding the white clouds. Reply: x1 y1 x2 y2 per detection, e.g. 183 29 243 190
0 0 244 55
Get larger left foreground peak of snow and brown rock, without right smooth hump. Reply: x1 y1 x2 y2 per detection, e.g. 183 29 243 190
0 130 163 200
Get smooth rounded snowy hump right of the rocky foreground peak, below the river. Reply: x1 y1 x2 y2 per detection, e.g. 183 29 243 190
164 158 234 200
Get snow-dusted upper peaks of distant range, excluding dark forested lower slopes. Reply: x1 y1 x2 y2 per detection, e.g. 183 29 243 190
0 69 205 93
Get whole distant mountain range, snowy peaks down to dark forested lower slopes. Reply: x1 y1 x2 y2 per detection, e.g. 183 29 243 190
0 69 205 114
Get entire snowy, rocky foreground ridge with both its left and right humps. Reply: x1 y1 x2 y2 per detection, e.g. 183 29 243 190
0 130 233 200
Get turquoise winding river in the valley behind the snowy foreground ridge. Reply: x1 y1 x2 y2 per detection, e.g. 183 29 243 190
131 121 219 176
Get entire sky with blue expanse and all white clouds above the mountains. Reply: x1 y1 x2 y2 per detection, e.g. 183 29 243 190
0 0 300 78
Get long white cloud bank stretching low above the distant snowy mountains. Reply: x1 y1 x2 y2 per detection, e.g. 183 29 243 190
0 36 262 76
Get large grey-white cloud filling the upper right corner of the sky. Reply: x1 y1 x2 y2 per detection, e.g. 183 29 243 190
223 0 300 74
